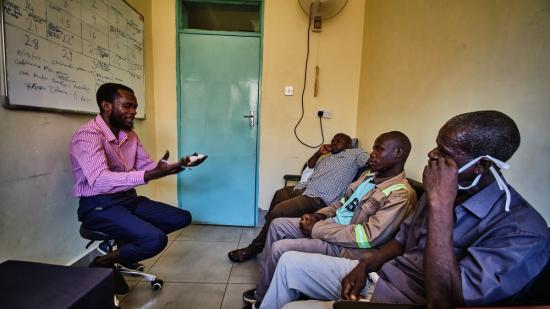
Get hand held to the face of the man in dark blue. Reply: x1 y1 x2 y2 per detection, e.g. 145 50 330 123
422 157 458 207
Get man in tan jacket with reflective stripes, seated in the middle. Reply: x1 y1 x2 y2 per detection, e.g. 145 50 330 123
243 131 416 307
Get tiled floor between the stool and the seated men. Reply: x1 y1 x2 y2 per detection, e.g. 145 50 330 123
121 225 260 309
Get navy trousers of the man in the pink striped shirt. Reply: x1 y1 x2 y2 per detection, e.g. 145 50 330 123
78 190 191 263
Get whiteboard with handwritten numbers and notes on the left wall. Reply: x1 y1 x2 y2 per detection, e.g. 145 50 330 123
0 0 145 118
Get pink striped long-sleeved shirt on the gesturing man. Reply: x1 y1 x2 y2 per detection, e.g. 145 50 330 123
69 115 156 197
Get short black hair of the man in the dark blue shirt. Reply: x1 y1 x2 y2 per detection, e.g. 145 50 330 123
443 110 520 162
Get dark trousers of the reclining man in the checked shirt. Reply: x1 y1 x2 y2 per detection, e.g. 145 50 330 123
250 186 326 253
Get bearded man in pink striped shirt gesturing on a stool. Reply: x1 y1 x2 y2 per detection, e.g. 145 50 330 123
69 83 207 294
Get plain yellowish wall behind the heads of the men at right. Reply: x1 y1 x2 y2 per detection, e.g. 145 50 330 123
357 0 550 222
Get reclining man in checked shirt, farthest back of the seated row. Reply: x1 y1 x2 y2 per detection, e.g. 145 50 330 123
228 133 368 262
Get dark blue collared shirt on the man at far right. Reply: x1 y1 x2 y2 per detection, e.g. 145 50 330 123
372 182 550 306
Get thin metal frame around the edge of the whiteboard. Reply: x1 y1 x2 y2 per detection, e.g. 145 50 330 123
0 0 147 120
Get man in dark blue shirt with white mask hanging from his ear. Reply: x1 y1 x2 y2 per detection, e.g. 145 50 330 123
261 111 550 308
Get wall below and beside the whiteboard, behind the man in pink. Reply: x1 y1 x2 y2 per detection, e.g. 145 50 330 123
0 0 155 264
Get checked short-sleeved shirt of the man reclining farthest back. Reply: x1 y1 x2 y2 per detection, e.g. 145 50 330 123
296 148 369 205
